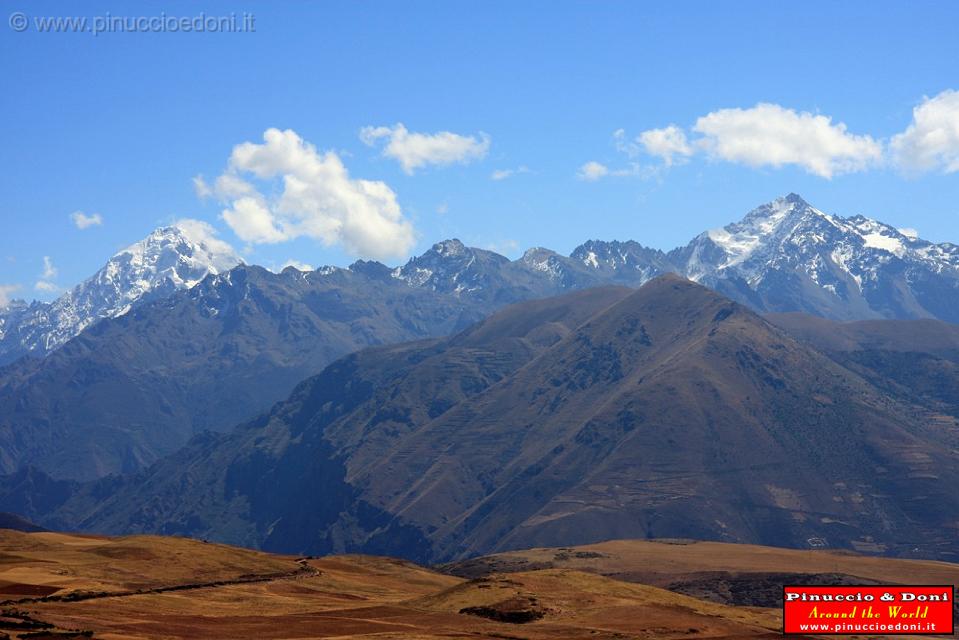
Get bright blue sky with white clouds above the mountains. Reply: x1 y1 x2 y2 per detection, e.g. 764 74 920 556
0 0 959 299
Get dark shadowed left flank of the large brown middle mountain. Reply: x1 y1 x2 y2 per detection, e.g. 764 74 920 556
41 287 631 560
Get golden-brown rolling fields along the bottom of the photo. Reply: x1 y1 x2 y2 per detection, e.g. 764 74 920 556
0 530 959 640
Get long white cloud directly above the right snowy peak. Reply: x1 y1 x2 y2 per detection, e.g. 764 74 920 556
693 103 882 178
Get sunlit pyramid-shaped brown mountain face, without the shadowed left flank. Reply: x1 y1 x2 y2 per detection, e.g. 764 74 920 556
348 276 957 557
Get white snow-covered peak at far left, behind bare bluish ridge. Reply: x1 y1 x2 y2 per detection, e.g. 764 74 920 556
0 220 242 361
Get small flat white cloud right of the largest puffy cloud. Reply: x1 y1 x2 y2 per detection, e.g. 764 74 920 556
360 123 490 175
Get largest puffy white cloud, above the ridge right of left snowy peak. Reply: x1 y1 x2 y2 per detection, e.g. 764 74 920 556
201 129 415 259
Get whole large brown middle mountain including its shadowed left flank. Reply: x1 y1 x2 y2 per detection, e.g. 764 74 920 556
18 276 959 561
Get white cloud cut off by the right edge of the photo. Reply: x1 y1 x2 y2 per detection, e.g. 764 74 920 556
890 90 959 173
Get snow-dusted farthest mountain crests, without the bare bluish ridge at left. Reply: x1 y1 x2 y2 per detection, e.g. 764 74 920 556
0 194 959 364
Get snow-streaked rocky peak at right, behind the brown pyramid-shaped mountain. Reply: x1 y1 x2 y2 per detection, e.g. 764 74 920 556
669 194 959 318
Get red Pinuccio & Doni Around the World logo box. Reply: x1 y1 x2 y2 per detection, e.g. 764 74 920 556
783 584 955 635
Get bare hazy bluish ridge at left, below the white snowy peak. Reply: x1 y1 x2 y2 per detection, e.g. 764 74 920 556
0 265 496 478
